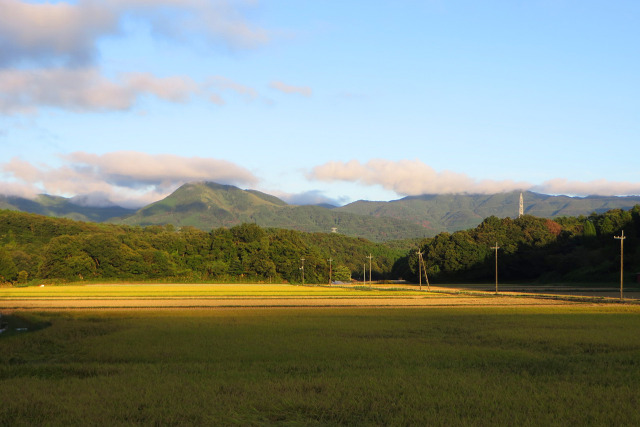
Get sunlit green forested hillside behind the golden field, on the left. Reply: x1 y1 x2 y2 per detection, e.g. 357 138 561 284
0 210 406 283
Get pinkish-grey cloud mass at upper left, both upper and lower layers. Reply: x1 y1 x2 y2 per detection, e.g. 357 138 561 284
0 0 271 114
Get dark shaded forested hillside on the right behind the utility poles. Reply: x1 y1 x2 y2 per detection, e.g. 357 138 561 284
396 205 640 283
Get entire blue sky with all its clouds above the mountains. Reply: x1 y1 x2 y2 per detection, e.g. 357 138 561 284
0 0 640 207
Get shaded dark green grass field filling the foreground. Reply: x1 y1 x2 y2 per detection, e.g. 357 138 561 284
0 305 640 426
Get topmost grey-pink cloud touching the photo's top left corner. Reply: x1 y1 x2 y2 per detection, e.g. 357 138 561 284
0 0 270 66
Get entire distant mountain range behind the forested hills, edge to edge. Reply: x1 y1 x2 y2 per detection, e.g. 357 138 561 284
0 182 640 241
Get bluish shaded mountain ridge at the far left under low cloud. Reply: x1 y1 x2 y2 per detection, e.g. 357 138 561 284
0 194 135 222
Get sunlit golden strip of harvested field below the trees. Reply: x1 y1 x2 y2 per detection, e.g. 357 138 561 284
0 284 589 309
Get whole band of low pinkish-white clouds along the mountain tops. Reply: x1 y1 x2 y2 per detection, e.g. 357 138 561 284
0 157 640 208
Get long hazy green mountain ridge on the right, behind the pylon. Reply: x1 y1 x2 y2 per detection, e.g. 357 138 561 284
335 191 640 232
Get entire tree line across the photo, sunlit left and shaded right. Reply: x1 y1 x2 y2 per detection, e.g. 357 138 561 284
0 205 640 283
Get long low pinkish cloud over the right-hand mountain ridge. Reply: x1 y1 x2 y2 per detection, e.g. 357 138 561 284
307 159 640 196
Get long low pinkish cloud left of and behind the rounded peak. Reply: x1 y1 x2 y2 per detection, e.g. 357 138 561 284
0 151 258 206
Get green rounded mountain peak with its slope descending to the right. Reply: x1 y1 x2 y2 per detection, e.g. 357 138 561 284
117 182 433 241
